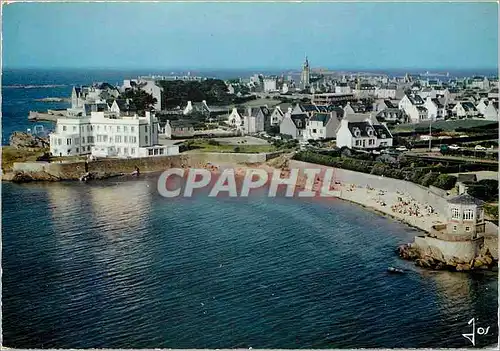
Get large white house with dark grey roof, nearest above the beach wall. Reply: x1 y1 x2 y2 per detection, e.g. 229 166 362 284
336 114 393 149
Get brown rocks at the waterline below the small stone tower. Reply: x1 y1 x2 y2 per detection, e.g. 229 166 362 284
396 244 498 272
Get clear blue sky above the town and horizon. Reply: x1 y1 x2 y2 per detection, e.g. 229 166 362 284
2 2 498 70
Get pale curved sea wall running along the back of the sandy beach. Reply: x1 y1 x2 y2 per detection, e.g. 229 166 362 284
289 160 448 214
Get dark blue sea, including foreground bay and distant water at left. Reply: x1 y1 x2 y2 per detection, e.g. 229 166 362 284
2 72 498 349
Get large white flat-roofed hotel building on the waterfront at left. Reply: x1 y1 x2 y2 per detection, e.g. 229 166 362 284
50 112 179 158
